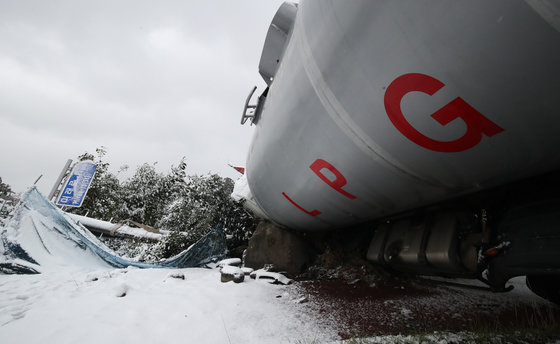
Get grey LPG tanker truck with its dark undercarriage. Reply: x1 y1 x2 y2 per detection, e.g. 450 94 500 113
237 0 560 303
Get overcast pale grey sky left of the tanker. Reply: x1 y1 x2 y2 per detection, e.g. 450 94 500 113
0 0 283 193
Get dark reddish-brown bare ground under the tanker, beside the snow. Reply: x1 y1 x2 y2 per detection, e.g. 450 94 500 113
296 279 560 339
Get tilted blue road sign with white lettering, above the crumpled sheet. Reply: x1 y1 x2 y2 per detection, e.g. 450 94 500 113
56 161 97 207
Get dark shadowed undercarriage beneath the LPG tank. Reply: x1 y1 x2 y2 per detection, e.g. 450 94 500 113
367 172 560 303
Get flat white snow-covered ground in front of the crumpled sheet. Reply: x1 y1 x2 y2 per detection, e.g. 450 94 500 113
0 268 338 344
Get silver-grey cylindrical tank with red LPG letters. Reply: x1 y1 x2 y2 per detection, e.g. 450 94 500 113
246 0 560 231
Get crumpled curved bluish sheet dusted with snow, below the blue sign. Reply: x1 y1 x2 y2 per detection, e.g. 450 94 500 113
0 187 231 273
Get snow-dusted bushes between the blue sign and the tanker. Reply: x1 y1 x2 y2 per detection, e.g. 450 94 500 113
68 147 256 258
